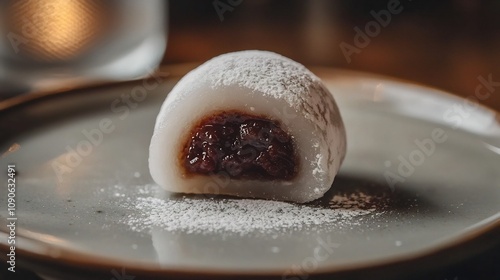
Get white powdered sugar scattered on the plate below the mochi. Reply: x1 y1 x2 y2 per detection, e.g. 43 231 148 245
118 185 386 235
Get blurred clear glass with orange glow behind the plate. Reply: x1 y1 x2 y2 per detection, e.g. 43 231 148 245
0 0 167 94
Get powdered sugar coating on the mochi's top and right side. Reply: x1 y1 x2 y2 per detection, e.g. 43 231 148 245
190 51 346 180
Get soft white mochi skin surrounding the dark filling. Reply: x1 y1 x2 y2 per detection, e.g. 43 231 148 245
149 51 346 203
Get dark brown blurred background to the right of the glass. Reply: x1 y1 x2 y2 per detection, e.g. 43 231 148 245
163 0 500 110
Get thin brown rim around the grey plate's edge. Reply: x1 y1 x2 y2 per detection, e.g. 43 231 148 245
0 63 500 277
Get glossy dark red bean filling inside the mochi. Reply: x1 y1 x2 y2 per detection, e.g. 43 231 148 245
181 111 297 180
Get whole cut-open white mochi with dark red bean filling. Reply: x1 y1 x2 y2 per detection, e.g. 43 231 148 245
149 51 346 203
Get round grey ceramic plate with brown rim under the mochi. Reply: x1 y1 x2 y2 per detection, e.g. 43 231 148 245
0 68 500 279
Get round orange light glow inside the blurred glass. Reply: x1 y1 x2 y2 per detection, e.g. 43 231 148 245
8 0 103 61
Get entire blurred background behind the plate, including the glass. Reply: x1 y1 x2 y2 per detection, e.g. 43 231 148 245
0 0 500 110
